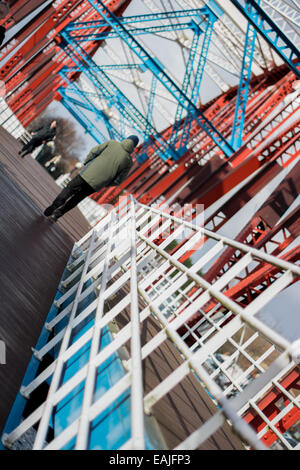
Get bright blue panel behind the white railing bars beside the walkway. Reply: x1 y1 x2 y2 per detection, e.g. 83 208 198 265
50 281 154 450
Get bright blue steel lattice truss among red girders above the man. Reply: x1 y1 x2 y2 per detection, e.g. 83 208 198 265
61 0 300 161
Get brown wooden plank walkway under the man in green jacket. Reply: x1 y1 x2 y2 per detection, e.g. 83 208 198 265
0 127 90 432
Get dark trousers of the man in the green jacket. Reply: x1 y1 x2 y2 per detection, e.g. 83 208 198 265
51 175 95 216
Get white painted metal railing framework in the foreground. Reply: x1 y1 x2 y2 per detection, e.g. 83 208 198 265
2 198 300 450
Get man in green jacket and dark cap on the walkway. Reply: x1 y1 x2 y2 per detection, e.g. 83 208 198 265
44 135 139 222
